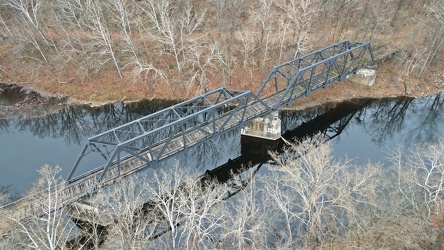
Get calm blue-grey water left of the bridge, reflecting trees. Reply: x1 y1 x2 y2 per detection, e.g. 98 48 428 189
0 100 175 193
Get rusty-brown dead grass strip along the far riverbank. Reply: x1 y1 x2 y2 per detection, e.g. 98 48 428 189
6 55 444 109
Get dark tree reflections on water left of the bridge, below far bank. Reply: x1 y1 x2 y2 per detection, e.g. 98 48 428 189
0 100 175 145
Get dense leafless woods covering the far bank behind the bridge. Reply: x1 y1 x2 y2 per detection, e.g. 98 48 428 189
0 0 444 98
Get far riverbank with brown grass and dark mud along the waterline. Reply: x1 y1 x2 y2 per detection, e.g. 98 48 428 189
0 60 444 119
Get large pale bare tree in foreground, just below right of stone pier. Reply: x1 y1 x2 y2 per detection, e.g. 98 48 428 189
266 138 378 246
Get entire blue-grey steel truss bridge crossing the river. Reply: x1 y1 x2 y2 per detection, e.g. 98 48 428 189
0 41 374 224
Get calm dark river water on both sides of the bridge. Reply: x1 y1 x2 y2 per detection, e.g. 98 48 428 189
0 94 444 194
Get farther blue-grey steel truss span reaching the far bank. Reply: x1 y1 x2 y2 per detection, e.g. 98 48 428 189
257 41 375 110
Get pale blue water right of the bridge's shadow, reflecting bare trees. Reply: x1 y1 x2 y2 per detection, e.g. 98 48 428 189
332 93 444 164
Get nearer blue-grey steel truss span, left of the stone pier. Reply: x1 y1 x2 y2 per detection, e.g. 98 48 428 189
68 88 270 182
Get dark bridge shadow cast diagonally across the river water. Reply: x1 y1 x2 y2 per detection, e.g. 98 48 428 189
66 100 374 248
